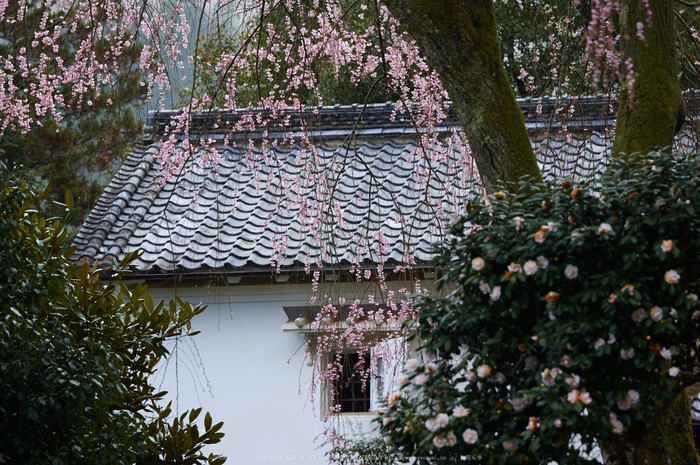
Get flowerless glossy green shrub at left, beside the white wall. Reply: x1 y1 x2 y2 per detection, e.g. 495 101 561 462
0 163 224 465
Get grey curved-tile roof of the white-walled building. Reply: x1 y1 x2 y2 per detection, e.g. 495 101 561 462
74 96 700 274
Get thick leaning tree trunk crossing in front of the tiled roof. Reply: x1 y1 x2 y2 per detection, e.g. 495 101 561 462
383 0 542 192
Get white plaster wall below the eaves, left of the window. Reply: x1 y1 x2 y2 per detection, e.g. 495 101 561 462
151 284 380 464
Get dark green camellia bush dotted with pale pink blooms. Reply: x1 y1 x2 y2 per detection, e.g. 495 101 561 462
378 152 700 464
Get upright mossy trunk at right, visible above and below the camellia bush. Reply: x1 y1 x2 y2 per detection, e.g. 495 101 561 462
606 0 700 465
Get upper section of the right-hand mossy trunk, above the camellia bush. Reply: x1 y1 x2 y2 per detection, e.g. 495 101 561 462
612 0 685 156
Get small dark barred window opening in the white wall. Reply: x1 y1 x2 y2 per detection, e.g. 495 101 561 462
336 353 371 413
